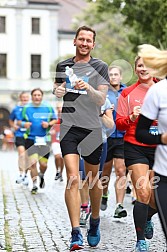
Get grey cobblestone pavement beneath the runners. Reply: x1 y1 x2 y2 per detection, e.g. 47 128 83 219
0 151 166 252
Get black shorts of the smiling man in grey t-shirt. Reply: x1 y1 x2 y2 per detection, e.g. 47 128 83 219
60 125 102 165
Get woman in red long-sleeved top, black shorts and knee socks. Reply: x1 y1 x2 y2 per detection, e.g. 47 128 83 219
116 57 157 252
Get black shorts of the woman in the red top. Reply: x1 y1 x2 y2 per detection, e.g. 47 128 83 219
124 142 155 169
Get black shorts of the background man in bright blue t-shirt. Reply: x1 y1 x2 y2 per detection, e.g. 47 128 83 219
25 139 50 159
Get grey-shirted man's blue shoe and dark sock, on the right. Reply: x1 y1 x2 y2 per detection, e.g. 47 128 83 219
87 217 100 247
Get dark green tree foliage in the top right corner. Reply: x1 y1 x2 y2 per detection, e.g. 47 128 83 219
87 0 167 52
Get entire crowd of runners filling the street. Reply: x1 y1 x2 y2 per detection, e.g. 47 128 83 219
6 26 167 252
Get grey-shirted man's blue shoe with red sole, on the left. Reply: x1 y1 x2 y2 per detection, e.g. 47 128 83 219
70 230 84 251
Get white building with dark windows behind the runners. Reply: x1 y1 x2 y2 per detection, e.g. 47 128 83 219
0 0 86 133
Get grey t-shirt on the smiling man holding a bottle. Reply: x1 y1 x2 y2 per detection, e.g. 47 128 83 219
55 58 110 129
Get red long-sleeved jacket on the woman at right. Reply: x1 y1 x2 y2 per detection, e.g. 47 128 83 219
116 81 157 147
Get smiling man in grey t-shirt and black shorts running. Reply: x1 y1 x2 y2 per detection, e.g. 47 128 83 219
53 26 109 251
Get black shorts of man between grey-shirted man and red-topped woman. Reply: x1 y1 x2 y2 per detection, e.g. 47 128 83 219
106 137 124 162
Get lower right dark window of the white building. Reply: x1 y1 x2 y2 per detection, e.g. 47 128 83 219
31 55 41 79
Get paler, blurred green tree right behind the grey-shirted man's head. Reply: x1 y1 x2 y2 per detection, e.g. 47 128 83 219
74 3 136 84
